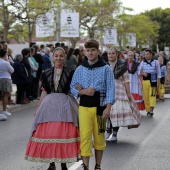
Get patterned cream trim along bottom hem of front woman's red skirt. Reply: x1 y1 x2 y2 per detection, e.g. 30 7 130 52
25 155 81 163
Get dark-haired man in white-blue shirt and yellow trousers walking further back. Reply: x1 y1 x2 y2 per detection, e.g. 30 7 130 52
138 49 161 117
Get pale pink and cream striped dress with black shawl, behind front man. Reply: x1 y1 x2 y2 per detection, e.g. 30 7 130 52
110 60 141 129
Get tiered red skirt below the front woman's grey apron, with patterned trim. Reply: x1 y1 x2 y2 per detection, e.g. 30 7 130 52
25 122 80 163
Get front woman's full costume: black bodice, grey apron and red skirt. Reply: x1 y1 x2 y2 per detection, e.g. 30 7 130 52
25 67 80 163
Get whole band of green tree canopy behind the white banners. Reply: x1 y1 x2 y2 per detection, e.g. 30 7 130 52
0 0 170 49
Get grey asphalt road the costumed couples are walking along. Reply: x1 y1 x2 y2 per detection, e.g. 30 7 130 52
0 99 170 170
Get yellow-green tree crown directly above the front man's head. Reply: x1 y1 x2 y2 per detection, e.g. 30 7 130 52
61 0 121 47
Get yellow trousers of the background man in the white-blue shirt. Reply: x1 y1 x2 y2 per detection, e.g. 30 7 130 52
142 80 156 112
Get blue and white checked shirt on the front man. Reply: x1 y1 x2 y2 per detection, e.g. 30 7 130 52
70 65 115 106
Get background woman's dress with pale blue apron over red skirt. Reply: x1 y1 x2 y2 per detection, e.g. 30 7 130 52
126 61 145 110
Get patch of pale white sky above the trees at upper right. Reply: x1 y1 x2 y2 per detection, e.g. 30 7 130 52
121 0 170 14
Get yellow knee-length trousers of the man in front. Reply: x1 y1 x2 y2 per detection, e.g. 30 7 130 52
79 106 106 156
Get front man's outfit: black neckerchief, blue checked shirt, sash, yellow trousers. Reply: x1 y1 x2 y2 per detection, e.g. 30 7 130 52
71 58 115 157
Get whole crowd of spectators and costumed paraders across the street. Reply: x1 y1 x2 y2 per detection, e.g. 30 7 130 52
0 39 170 170
